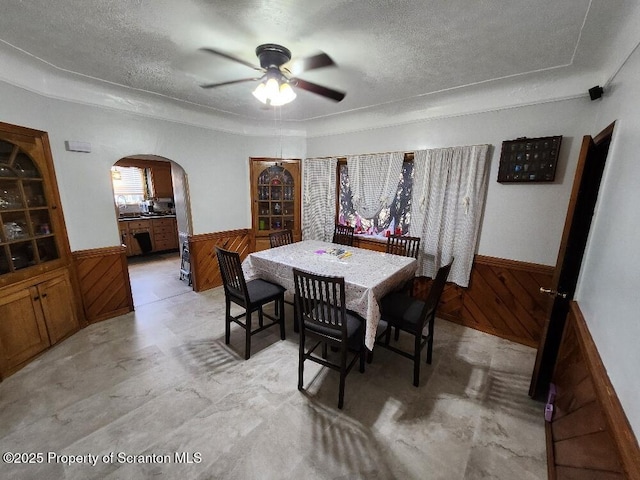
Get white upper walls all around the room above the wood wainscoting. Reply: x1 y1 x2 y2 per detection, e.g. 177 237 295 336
0 52 640 435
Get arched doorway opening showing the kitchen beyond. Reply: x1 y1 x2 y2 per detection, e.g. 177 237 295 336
111 155 193 308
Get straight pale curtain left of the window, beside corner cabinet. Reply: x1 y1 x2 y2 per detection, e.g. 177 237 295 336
302 157 338 242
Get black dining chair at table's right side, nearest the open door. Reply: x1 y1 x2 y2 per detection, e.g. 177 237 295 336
376 259 453 387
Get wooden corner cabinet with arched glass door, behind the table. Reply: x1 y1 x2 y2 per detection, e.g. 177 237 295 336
250 158 302 255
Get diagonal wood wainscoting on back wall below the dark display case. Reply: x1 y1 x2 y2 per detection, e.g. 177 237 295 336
414 255 553 347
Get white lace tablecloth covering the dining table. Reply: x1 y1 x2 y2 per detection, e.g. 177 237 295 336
242 240 417 350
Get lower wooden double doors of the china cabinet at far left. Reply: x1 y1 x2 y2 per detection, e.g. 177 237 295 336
0 269 80 378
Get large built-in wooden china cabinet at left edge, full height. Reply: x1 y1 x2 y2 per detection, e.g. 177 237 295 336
0 122 81 379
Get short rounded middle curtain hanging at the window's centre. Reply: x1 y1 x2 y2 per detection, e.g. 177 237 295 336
347 152 404 219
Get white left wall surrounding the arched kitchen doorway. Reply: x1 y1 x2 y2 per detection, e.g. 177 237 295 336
0 82 305 251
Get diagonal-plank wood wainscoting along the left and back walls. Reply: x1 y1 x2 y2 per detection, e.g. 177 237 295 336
73 229 553 347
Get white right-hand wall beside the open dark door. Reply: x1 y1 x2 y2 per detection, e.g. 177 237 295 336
576 43 640 437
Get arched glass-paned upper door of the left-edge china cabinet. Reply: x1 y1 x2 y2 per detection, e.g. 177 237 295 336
0 140 59 275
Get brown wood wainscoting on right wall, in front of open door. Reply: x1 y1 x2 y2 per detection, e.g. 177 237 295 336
547 302 640 480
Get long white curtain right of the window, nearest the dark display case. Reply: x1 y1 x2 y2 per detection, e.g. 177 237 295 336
409 145 489 287
